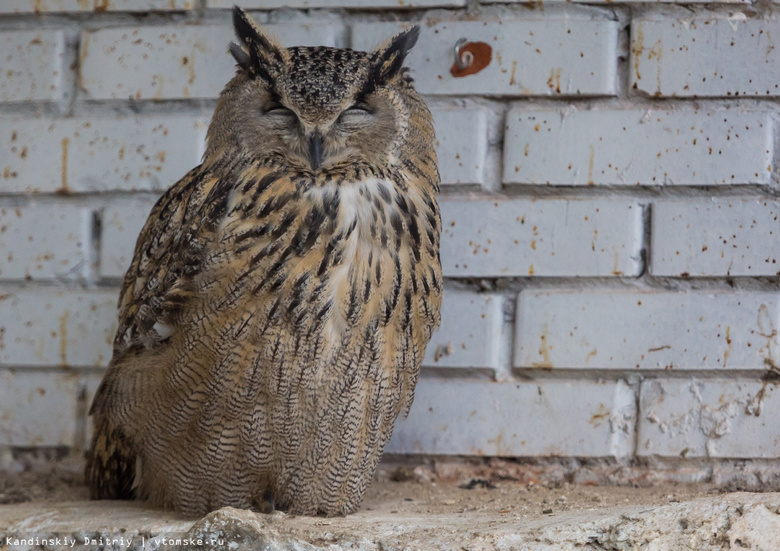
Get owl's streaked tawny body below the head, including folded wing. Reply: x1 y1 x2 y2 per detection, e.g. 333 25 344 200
87 160 442 514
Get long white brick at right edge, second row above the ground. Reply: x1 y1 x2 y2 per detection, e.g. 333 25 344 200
514 290 780 370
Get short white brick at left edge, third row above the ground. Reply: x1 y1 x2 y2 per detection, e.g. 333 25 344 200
0 205 92 279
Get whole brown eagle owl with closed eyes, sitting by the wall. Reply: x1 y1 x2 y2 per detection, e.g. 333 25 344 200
86 8 442 516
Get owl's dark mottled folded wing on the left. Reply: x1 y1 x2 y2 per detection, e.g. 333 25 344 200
114 167 229 358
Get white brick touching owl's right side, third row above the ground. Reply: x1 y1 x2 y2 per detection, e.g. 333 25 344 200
441 199 642 277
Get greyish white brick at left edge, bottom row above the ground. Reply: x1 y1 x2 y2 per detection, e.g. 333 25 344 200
0 369 79 447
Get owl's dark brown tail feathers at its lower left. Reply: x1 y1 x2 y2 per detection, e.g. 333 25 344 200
85 415 136 499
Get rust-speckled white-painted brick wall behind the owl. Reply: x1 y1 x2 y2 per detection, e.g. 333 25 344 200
0 0 780 470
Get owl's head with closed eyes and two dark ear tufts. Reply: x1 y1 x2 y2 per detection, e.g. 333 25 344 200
206 7 419 177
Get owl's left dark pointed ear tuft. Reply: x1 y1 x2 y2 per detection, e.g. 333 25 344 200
230 6 287 81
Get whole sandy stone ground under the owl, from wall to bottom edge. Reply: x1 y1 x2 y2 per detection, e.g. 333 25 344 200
0 465 780 551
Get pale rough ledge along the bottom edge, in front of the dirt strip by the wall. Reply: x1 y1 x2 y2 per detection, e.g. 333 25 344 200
0 492 780 551
